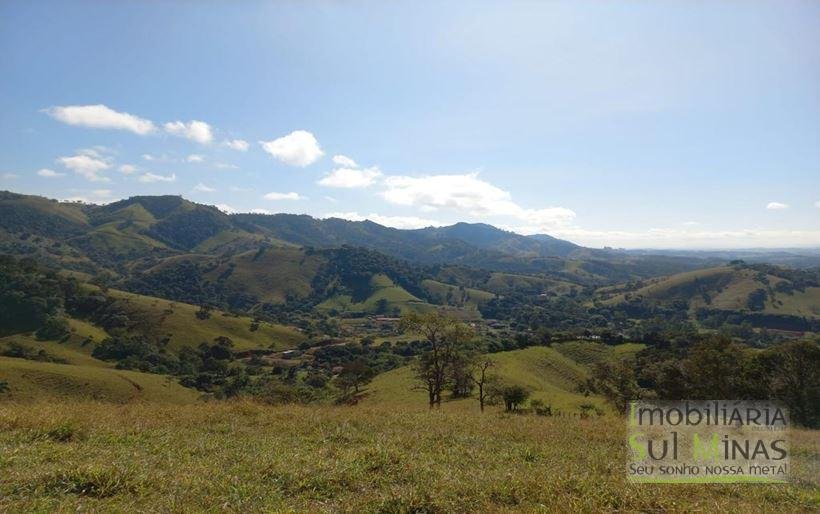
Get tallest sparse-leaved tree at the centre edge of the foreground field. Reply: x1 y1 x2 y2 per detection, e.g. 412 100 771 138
400 311 474 409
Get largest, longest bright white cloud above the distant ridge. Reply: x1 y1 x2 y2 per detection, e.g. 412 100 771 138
381 173 575 233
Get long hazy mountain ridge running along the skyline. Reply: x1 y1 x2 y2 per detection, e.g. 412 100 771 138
0 192 768 285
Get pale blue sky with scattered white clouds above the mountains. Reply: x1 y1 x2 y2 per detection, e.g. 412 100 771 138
0 0 820 249
